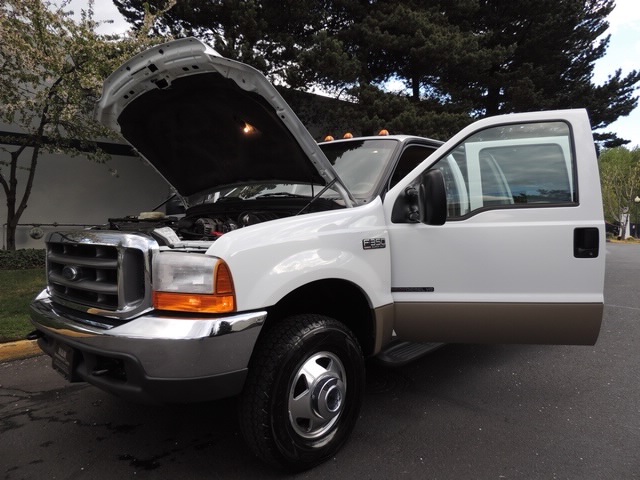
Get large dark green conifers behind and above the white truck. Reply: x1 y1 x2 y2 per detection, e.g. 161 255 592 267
114 0 640 148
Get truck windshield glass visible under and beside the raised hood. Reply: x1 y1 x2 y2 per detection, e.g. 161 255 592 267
190 139 397 205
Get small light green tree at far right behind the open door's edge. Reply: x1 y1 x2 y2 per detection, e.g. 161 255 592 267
600 147 640 231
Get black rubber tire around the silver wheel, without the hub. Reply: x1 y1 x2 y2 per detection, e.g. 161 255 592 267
238 314 365 471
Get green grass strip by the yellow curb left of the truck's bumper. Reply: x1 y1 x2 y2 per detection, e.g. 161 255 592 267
0 268 46 342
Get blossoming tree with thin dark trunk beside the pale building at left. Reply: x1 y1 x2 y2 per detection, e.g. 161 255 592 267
0 0 166 249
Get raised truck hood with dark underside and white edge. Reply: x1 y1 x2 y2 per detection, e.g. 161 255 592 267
95 38 353 205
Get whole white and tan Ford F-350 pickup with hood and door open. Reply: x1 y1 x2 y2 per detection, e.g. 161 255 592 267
31 38 605 470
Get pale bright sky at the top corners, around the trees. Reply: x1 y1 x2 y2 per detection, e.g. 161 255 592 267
70 0 640 148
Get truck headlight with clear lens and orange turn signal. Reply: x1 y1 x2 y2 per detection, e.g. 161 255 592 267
153 252 236 313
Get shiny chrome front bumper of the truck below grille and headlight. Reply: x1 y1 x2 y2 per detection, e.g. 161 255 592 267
31 291 267 403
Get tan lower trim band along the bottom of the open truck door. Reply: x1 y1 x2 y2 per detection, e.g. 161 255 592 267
390 302 604 345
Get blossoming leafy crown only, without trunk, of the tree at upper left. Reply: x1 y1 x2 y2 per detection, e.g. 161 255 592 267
0 0 143 159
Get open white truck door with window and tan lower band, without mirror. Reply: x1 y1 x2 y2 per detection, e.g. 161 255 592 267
385 111 604 343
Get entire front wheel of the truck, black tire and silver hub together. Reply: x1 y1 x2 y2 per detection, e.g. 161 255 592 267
239 314 364 471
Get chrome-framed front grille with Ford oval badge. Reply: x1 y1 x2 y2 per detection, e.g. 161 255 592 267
47 230 157 319
